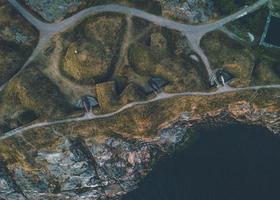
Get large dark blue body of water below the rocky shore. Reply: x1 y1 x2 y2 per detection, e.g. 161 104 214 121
124 125 280 200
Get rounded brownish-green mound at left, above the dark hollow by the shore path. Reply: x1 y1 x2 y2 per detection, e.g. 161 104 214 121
4 69 71 117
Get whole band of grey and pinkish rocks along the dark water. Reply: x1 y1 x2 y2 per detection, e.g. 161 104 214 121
0 101 280 200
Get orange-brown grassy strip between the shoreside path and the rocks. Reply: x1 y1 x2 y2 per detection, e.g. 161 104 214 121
58 90 280 137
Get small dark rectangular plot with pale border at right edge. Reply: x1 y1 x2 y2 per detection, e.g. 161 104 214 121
265 16 280 46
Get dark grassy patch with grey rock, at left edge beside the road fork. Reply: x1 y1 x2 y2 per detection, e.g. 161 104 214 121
0 2 38 85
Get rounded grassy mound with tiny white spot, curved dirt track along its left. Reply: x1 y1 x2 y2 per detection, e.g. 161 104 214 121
62 15 125 84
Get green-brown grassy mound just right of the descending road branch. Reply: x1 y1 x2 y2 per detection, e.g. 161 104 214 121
202 32 255 87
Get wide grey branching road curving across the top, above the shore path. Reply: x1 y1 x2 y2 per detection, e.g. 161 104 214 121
3 0 268 86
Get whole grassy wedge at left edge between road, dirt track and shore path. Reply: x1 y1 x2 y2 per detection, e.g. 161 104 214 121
0 68 74 133
